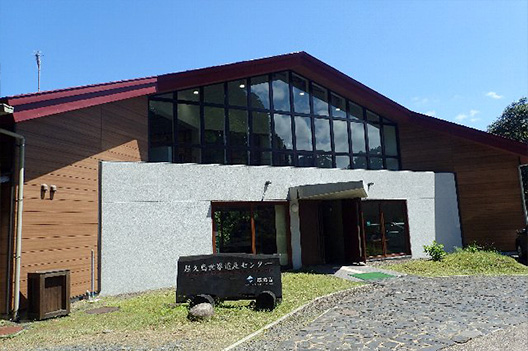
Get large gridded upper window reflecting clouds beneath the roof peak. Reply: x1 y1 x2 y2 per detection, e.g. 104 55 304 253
149 71 400 170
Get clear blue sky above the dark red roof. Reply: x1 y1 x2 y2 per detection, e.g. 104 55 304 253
0 0 528 130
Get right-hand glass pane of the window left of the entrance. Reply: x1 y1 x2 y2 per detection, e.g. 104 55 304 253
253 205 277 254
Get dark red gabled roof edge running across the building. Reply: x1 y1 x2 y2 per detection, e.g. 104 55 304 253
0 51 528 156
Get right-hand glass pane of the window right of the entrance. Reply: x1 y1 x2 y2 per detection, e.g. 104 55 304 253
381 201 409 255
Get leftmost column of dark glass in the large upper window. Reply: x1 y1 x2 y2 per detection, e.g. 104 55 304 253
149 100 174 152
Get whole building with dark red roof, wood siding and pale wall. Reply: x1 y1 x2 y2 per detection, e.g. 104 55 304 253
0 52 528 314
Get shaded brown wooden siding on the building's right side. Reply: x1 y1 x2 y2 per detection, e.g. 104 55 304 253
399 124 524 251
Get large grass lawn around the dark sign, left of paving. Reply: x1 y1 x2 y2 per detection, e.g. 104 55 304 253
0 273 358 350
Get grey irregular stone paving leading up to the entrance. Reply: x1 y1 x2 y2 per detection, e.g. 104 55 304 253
244 276 528 350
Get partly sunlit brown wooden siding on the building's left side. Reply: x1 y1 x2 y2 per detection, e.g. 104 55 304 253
11 97 148 308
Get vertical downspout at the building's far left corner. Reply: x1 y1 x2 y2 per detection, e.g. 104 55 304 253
0 128 26 321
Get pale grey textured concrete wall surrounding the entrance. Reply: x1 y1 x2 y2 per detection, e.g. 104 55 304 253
101 162 460 295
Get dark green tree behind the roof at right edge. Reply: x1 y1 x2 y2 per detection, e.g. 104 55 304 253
488 97 528 143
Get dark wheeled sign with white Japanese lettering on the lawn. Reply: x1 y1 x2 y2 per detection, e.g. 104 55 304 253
176 254 282 309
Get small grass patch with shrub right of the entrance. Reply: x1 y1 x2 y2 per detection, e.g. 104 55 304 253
384 250 528 277
